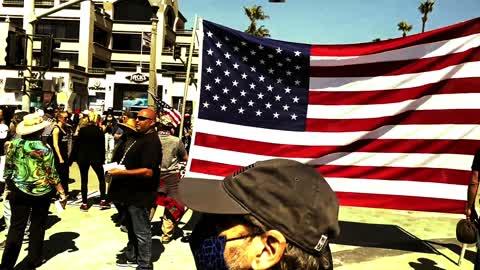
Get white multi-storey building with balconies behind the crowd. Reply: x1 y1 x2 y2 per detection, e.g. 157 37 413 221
0 0 198 112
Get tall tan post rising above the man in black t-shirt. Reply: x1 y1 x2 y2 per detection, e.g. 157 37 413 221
148 0 162 105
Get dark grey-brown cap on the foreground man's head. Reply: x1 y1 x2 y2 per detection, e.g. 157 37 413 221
179 159 340 255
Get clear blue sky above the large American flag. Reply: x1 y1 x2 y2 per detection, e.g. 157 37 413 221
180 0 480 44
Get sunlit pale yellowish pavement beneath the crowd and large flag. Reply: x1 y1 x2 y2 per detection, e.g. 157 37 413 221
0 164 476 270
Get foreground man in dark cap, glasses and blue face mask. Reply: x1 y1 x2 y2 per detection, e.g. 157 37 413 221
179 159 340 270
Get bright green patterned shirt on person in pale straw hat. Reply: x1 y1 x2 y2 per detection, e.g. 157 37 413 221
4 139 60 196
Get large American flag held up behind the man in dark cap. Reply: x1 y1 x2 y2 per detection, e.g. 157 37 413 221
187 18 480 213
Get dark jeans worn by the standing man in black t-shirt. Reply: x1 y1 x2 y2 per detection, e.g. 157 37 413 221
125 205 153 270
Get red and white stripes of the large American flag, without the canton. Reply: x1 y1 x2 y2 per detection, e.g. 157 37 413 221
187 18 480 213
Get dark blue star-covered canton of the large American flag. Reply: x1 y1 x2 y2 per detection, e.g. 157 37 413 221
198 20 310 131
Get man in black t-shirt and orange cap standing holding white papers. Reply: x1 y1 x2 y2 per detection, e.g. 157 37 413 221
108 109 162 269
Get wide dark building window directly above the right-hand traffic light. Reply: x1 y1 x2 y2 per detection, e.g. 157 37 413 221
36 20 80 41
